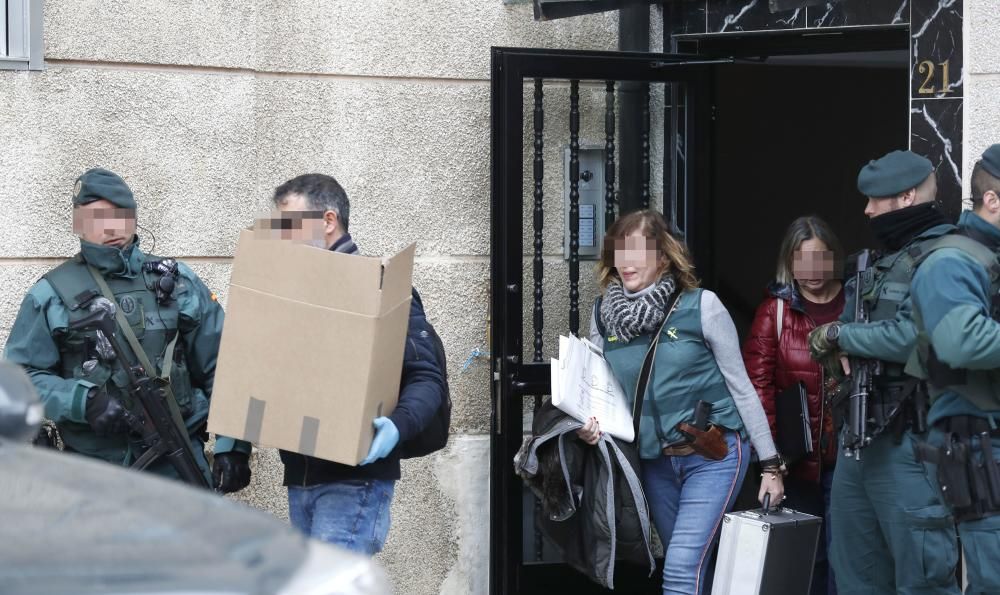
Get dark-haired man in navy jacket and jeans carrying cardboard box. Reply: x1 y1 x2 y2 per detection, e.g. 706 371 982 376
273 174 445 555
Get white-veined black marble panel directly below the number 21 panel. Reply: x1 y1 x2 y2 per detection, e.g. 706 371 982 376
910 98 963 220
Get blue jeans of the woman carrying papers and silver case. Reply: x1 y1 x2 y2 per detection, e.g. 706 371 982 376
641 432 750 595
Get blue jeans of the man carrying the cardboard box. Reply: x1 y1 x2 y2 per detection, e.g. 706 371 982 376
288 479 396 556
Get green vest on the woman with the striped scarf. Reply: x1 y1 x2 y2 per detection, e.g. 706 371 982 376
604 289 743 459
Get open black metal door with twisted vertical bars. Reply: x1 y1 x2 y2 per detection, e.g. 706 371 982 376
490 48 730 595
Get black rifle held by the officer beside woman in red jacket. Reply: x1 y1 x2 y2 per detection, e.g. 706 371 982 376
844 250 881 461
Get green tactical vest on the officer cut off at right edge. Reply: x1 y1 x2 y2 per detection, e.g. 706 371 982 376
906 234 1000 411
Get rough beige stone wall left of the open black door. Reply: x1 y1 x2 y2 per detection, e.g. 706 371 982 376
0 0 617 595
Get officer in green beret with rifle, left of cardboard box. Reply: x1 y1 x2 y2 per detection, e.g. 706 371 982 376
4 169 250 492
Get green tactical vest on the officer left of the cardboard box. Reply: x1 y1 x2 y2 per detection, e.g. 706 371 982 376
44 255 194 462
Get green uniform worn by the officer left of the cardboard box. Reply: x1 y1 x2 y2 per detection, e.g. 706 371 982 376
4 170 250 483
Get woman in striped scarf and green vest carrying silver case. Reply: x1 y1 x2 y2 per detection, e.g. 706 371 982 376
579 210 784 595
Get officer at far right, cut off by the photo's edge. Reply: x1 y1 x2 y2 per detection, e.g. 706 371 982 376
907 144 1000 594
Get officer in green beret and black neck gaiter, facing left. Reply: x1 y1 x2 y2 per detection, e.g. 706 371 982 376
809 151 959 595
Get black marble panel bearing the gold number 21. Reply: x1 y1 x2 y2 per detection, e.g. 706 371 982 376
910 0 965 99
